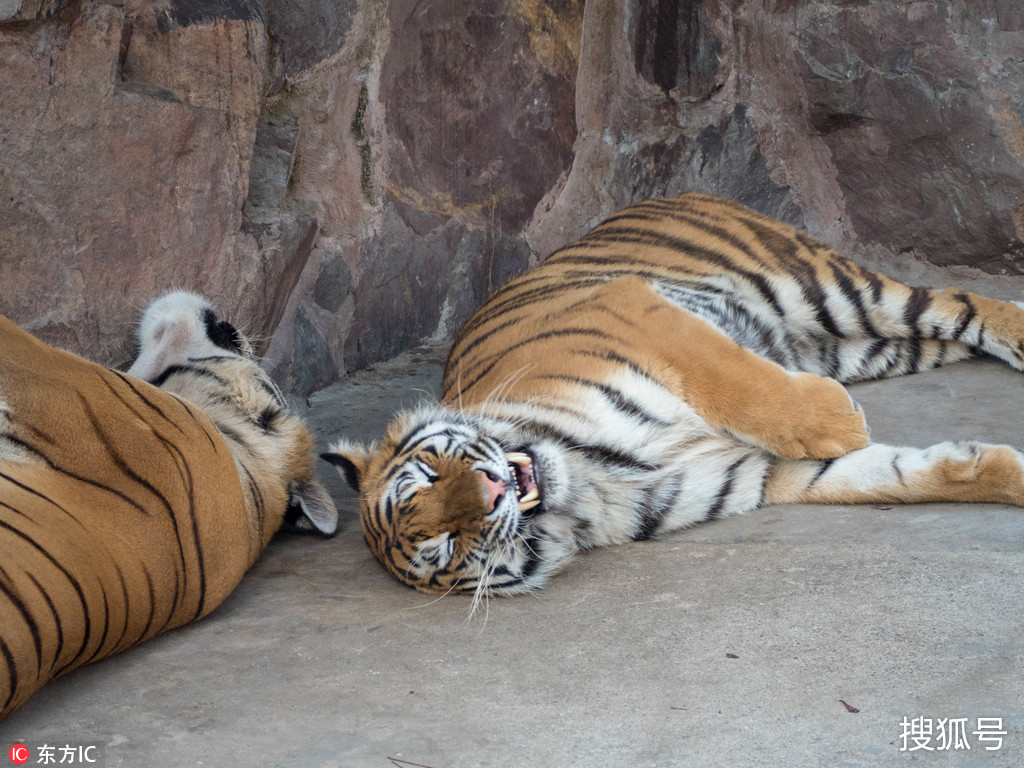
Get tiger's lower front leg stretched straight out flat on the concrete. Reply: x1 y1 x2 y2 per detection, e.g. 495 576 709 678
764 441 1024 507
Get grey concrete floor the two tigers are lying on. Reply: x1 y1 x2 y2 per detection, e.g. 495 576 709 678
0 350 1024 768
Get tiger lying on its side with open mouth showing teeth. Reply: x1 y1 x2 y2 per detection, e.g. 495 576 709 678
324 194 1024 595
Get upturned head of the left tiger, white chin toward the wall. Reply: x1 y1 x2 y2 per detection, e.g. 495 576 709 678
127 291 338 560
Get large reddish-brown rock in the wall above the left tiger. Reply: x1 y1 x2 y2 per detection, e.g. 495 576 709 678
0 2 303 362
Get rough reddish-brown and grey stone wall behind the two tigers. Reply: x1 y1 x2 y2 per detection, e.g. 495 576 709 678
0 0 1024 394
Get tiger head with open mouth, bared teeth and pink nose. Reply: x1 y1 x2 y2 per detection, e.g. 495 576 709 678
321 406 574 596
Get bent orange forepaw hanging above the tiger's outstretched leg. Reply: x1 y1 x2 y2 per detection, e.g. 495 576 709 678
767 374 869 459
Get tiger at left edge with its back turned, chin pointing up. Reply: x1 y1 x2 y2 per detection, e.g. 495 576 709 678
0 292 337 719
